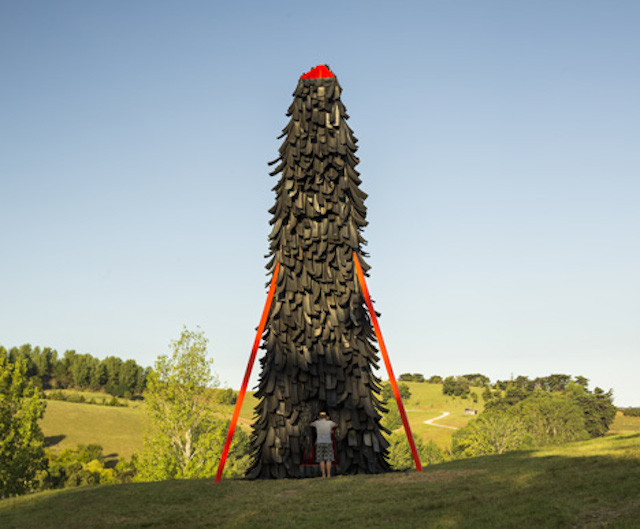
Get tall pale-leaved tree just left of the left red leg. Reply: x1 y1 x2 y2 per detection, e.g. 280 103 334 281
139 328 247 481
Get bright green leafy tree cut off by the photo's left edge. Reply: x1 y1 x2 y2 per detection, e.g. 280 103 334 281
0 355 46 497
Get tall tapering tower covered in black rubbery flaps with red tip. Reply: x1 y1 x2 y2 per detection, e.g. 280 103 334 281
247 66 389 478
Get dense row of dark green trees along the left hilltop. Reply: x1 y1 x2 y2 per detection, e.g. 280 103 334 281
0 344 150 398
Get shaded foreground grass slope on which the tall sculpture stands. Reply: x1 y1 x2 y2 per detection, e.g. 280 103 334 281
0 433 640 529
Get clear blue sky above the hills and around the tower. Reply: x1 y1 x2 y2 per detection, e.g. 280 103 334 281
0 0 640 406
